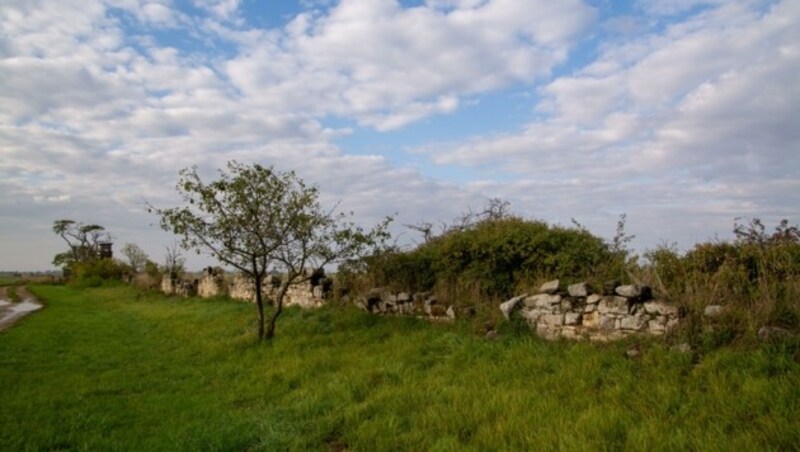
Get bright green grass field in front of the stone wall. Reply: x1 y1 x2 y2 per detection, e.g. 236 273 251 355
0 286 800 451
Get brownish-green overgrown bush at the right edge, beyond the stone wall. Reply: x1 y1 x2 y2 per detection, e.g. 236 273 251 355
639 219 800 346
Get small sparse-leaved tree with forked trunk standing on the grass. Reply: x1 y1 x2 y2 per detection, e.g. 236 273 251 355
151 162 390 339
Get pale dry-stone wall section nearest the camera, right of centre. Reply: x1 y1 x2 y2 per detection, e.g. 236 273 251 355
500 280 682 340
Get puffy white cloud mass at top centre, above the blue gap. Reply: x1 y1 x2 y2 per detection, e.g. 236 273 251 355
226 0 594 130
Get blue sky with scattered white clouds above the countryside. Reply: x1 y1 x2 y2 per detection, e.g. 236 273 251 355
0 0 800 271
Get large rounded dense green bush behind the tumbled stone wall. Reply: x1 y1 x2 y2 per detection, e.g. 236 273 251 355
339 215 625 311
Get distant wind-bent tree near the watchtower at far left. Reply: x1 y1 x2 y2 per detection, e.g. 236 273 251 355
53 219 111 269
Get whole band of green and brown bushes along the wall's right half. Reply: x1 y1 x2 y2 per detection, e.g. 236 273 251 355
352 214 800 348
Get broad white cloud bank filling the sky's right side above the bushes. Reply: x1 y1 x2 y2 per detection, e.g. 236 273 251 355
418 1 800 246
